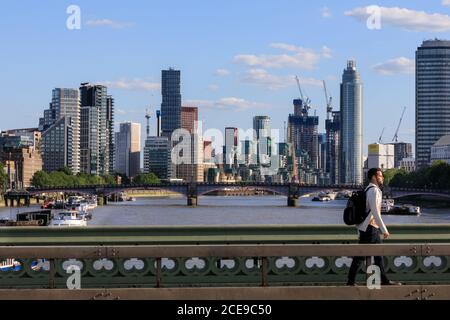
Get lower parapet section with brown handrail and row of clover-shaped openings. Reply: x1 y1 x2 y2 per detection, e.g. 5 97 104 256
0 243 450 289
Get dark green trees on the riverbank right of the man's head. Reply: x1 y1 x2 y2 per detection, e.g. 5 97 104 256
386 161 450 189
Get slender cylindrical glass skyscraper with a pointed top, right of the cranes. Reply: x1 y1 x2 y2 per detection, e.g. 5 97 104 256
340 60 363 184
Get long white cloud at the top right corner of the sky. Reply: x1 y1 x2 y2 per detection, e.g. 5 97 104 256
344 6 450 32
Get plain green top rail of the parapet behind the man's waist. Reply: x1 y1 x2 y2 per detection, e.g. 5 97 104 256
0 224 450 246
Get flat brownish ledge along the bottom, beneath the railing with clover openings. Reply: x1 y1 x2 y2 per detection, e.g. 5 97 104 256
0 285 450 300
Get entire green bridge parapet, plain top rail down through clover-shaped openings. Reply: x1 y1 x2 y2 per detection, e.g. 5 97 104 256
0 224 450 288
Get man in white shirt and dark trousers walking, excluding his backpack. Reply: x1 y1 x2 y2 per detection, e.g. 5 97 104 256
347 168 400 286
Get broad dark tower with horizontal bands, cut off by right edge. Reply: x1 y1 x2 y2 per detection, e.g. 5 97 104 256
416 40 450 169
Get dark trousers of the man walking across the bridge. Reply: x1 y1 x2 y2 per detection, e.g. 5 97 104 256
348 225 389 283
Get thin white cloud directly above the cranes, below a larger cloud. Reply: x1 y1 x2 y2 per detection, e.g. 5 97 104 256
240 69 322 90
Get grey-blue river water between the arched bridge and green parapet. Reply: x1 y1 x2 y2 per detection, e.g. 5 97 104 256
0 196 450 226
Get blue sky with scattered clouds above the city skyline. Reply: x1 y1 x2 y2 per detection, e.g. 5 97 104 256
0 0 450 153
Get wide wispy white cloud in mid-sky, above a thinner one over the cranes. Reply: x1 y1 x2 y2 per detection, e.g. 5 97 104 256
234 42 331 70
